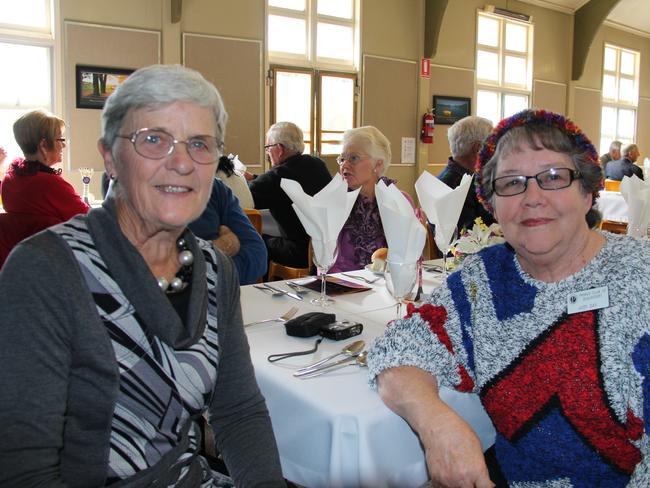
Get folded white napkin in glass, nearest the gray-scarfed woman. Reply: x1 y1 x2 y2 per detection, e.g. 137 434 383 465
280 173 360 269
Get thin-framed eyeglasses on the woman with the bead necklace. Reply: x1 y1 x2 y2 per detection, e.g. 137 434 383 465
117 128 223 164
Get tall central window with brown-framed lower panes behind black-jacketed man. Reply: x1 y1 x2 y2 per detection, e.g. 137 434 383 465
268 0 358 156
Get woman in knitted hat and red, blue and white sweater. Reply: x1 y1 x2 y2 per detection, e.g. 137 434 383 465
369 110 650 487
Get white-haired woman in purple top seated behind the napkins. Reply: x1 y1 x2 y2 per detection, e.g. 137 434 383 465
330 125 413 273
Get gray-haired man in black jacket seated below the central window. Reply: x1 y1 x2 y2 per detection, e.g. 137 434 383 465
249 122 332 268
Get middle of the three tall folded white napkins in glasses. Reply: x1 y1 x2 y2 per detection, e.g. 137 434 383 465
375 180 427 263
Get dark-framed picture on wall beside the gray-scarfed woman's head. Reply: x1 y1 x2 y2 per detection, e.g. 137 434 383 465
75 64 134 109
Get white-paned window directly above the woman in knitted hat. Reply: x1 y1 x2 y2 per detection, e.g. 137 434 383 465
476 12 533 124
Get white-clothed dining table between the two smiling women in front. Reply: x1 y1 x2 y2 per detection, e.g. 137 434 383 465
241 269 495 488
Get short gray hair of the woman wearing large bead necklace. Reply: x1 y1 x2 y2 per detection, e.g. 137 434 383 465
100 64 228 149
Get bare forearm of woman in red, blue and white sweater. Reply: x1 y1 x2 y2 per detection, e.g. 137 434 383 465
377 366 494 488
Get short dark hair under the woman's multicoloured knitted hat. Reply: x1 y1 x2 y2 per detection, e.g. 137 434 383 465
480 124 602 228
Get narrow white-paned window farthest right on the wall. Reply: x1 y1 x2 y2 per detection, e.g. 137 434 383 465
600 44 641 154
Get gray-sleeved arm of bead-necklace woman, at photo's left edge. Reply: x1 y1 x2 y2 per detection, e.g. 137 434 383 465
0 234 78 487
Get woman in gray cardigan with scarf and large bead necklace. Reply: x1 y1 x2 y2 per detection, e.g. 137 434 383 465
0 65 285 487
